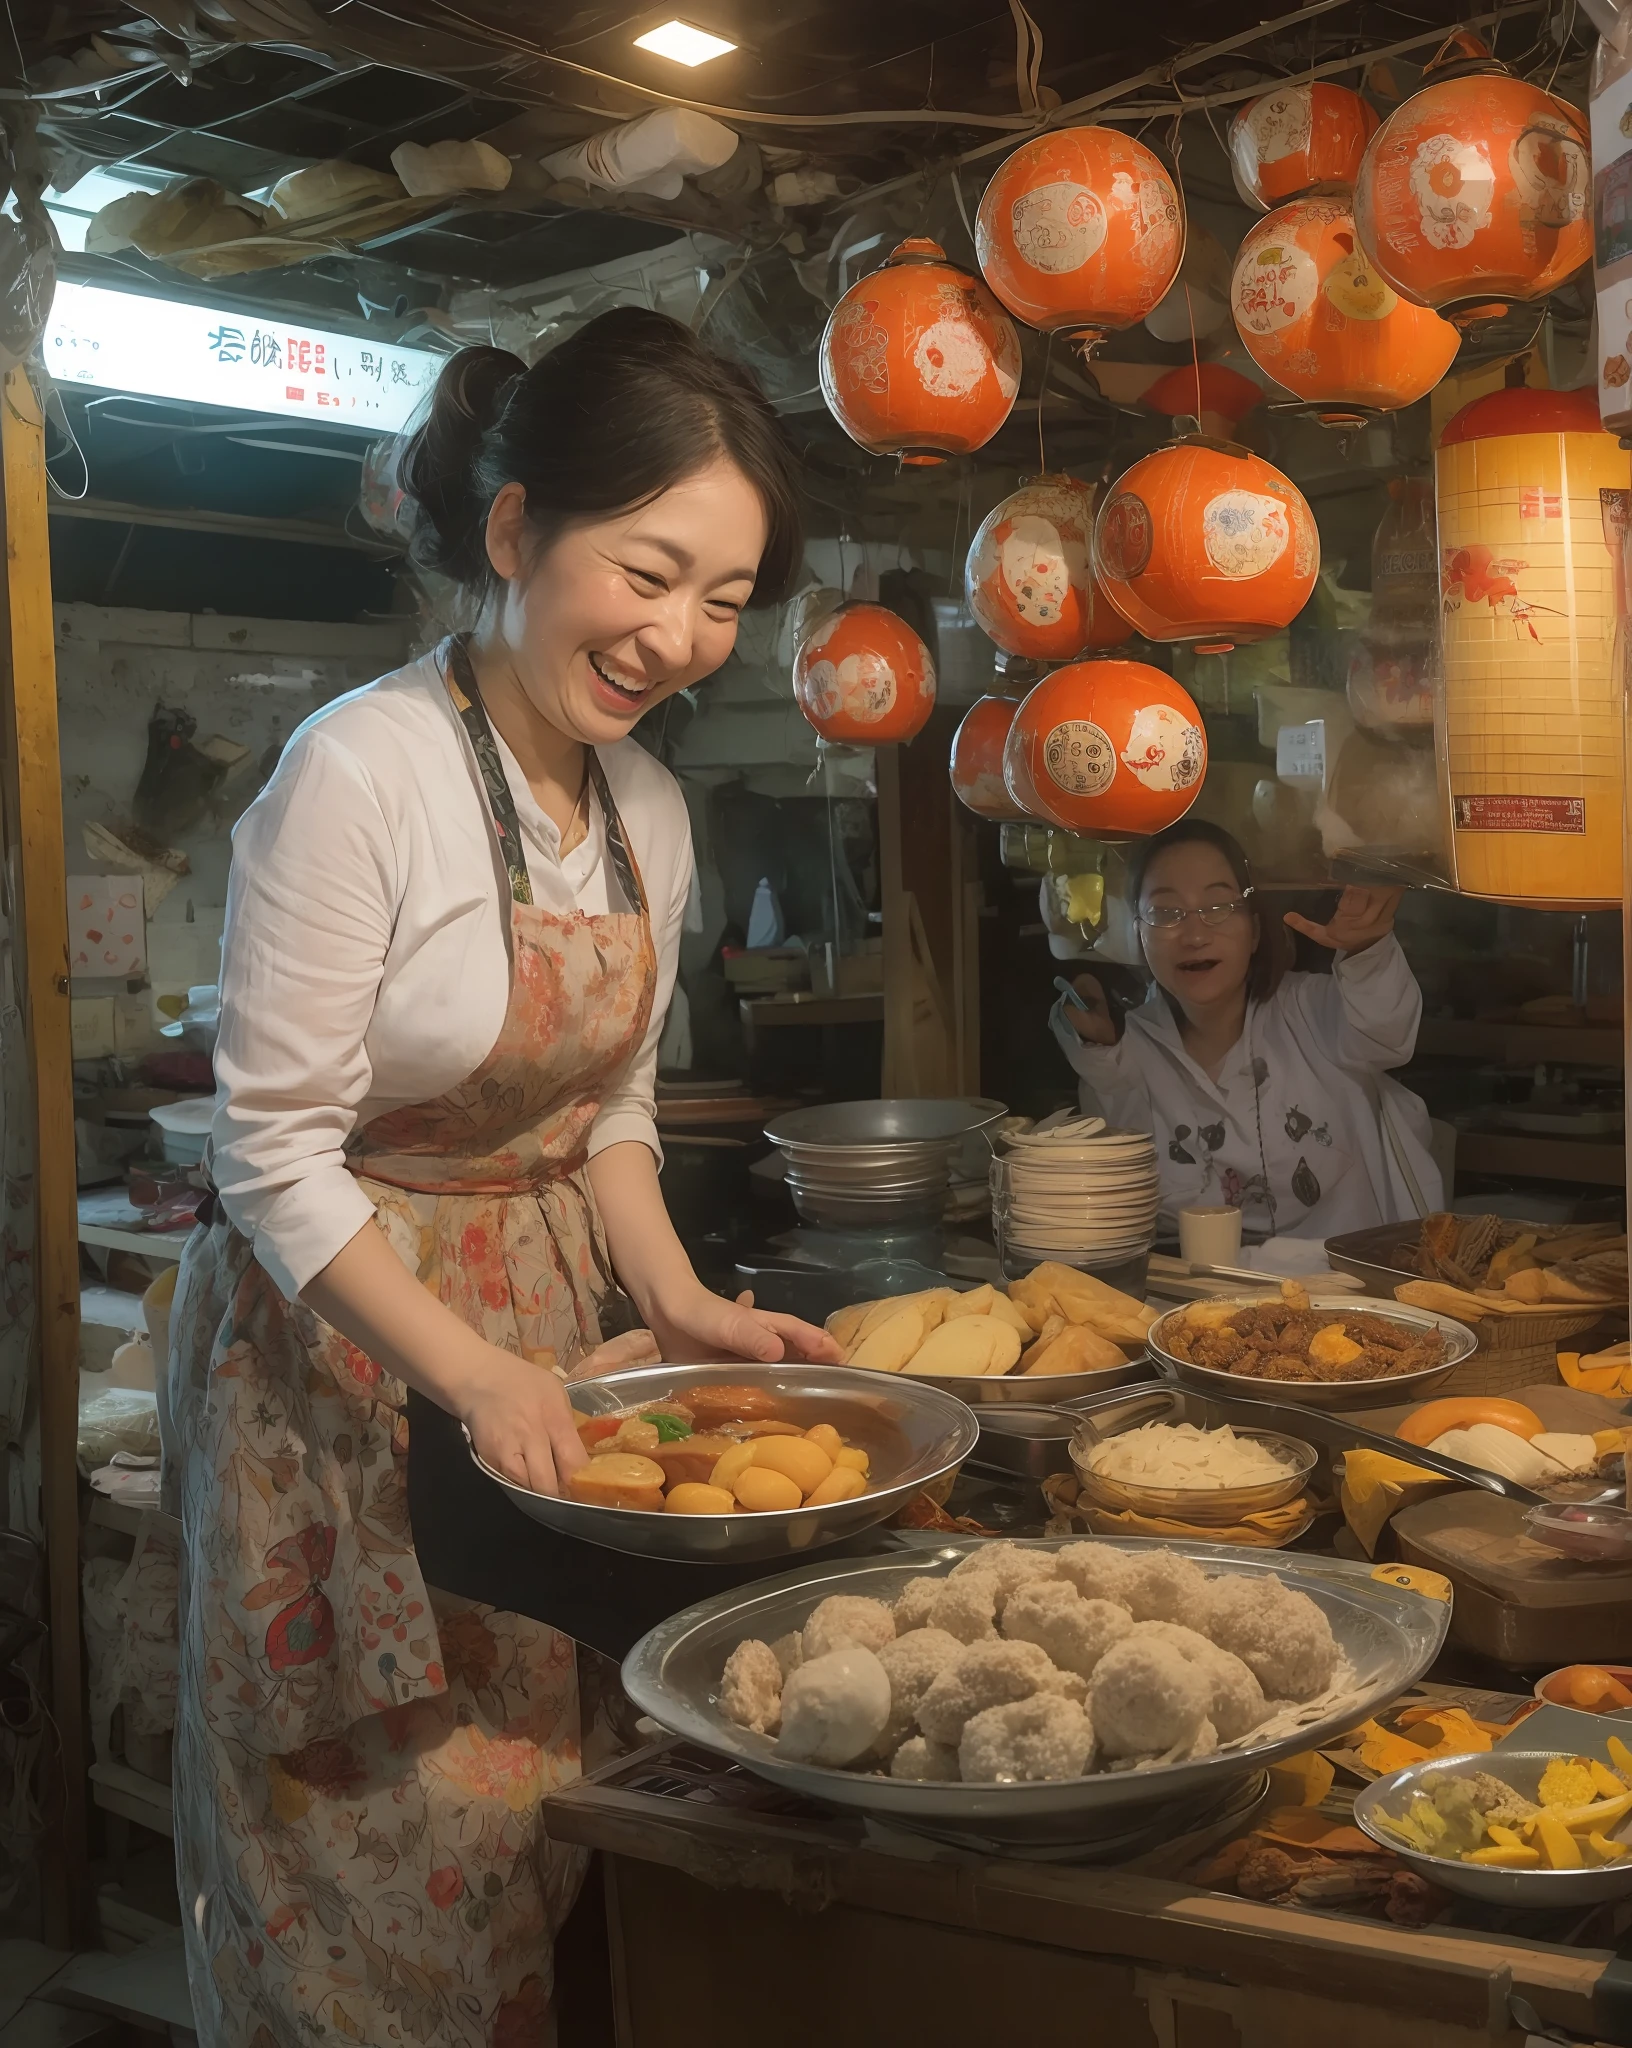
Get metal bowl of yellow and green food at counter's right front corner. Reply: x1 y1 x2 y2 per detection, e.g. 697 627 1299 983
1354 1749 1632 1911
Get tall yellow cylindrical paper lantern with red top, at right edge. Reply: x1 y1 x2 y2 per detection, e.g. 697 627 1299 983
1435 385 1632 909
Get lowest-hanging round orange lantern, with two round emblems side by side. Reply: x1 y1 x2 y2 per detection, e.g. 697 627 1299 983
1010 659 1206 838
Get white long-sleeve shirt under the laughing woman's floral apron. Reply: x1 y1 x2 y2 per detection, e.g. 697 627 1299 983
211 655 692 1298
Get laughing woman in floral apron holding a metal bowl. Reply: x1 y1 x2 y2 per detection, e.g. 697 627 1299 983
166 307 840 2048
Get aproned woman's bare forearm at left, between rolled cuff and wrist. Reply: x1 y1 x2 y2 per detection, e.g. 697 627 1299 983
301 1223 493 1415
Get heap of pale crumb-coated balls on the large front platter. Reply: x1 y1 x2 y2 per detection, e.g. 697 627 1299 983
719 1542 1339 1784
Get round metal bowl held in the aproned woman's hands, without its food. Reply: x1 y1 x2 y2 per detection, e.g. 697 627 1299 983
471 1362 981 1565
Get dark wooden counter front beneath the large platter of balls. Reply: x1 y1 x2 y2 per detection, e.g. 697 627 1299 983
547 1745 1632 2048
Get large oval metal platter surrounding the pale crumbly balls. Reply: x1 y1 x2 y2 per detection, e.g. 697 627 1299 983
622 1536 1450 1843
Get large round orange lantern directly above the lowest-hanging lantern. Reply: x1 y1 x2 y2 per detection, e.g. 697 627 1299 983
1093 436 1321 653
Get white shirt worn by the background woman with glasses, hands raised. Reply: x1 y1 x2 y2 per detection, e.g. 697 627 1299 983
1048 936 1444 1237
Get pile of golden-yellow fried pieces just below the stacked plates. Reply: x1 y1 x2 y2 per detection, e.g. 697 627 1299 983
827 1262 1155 1378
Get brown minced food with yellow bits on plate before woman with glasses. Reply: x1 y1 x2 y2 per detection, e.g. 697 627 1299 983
1165 1280 1446 1380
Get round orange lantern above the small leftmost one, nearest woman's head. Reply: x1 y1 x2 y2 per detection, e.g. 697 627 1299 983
821 238 1020 463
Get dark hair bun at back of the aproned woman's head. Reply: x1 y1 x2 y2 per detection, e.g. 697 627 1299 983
397 348 526 584
